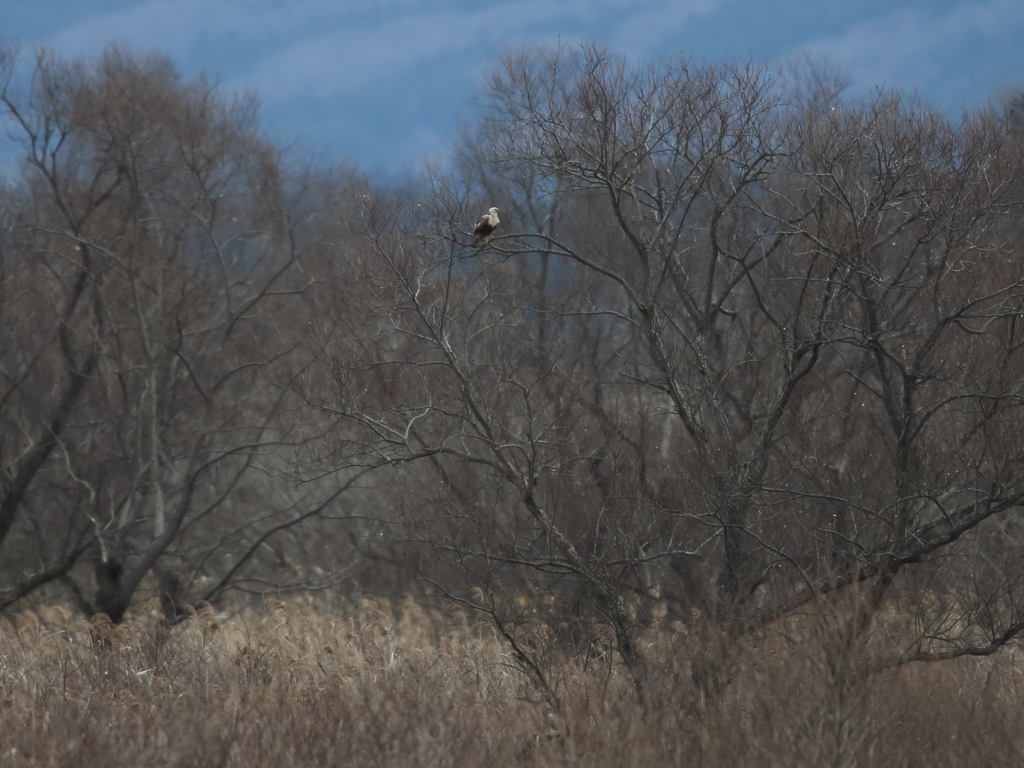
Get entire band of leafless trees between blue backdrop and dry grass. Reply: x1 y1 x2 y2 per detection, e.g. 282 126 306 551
0 45 1024 700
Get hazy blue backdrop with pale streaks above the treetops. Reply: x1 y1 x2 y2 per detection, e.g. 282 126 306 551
8 0 1024 180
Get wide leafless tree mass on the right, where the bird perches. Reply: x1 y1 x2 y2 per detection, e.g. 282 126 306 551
307 40 1024 704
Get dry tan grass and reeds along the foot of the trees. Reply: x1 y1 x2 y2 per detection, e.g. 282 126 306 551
0 601 1024 768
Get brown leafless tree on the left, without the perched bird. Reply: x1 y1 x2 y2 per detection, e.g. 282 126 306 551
0 48 368 621
